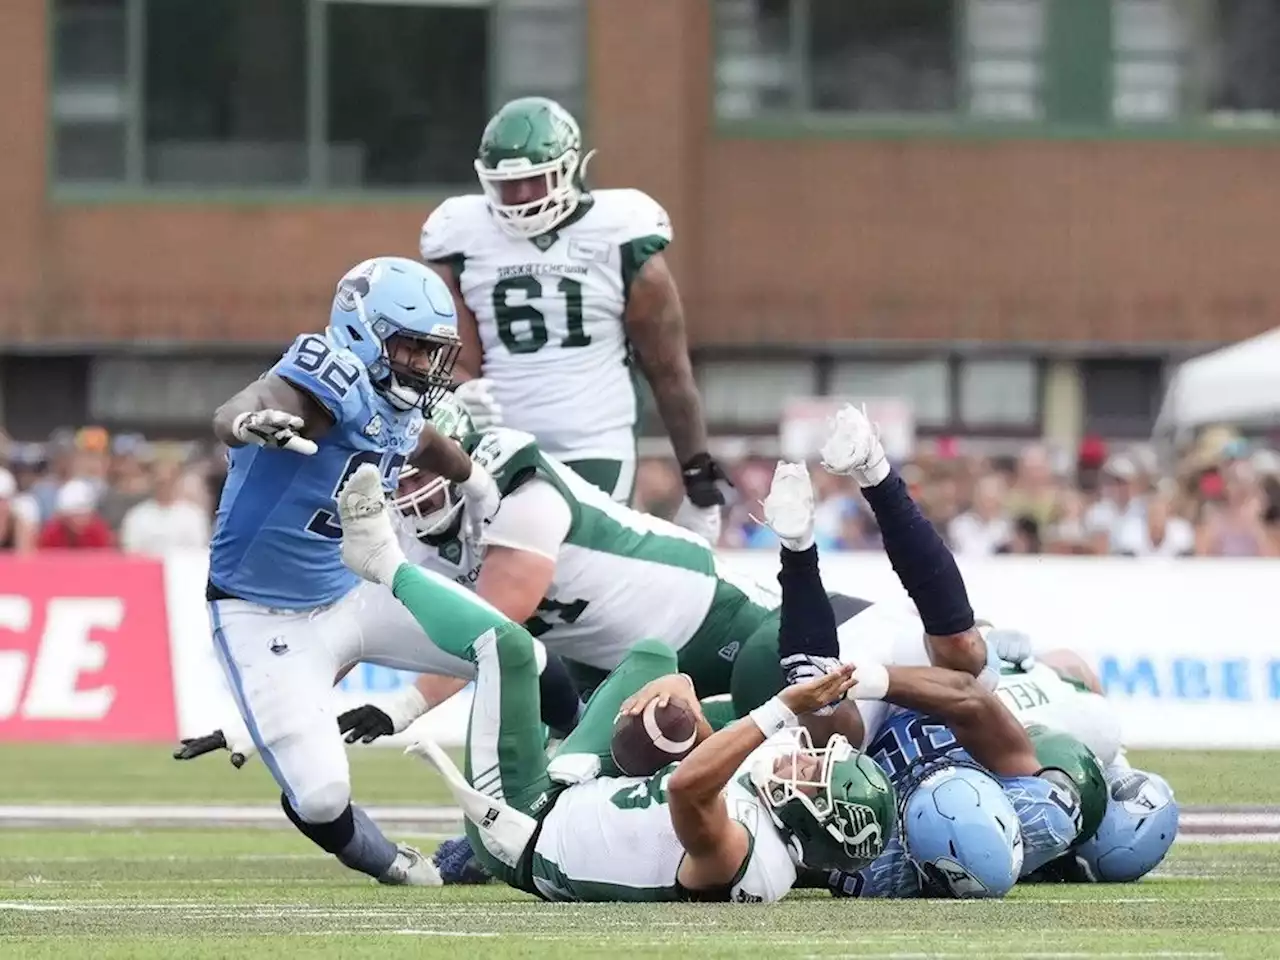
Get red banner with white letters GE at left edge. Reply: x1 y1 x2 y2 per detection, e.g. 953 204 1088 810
0 552 177 741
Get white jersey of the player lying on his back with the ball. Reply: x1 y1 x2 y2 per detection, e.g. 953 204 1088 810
534 731 796 904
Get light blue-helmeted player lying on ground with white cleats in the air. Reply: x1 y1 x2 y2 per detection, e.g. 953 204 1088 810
732 455 1102 896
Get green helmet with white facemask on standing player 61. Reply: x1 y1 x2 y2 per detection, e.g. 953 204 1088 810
475 97 595 239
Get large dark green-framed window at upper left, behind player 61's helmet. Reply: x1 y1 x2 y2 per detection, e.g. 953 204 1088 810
51 0 585 189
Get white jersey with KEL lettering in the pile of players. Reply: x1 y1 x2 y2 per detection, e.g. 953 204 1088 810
996 663 1123 767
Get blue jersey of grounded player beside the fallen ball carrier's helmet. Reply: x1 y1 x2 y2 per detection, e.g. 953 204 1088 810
833 710 1080 897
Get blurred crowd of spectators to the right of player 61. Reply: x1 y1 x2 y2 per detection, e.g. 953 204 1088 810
636 428 1280 557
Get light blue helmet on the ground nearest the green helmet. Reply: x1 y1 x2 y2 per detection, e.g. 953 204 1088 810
899 762 1023 899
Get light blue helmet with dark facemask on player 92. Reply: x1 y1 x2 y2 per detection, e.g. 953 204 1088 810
325 257 462 411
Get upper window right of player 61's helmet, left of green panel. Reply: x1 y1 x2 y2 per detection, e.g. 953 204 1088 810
716 0 1046 119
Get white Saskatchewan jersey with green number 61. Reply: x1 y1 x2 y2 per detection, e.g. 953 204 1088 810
420 189 672 461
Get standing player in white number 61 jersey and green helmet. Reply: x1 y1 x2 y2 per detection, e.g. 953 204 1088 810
420 97 728 544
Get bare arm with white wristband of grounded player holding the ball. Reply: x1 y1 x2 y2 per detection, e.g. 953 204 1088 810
667 666 854 890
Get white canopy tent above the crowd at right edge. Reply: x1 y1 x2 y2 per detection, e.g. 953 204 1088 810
1156 328 1280 435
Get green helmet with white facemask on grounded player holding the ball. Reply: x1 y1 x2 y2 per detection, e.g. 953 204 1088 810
750 727 896 870
